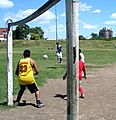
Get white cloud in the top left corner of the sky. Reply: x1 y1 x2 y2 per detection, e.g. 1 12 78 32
0 0 14 8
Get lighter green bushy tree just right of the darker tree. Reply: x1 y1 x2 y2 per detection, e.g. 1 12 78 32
30 27 44 40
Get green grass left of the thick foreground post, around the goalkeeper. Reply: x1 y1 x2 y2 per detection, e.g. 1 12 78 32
0 41 66 106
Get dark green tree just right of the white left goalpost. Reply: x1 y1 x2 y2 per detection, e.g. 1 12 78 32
13 24 30 40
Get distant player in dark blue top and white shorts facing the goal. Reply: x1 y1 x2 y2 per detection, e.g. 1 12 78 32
56 42 62 63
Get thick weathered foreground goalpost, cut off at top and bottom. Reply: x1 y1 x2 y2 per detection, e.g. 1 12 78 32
65 0 79 120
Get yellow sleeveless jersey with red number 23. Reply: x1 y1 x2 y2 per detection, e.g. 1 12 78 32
18 58 35 85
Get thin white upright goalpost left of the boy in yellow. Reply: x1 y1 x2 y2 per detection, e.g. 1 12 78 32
7 20 13 106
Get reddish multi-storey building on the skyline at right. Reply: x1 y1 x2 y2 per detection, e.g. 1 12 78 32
99 27 113 38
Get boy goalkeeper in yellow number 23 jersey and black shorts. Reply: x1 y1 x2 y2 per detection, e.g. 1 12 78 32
15 50 44 108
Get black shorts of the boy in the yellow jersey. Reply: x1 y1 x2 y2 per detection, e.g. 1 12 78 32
20 83 39 94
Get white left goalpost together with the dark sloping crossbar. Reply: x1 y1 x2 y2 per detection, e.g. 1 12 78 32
6 0 60 106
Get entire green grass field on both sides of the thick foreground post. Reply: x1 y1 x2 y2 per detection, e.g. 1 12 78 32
0 40 116 102
